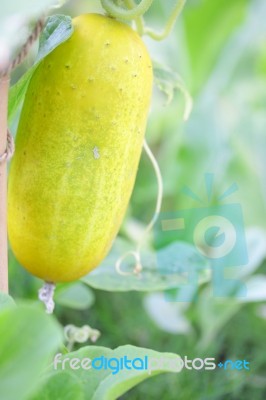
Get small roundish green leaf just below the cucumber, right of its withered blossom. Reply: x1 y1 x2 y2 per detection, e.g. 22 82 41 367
55 282 94 310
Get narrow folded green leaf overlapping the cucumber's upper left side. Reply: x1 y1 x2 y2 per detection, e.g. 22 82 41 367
8 15 73 121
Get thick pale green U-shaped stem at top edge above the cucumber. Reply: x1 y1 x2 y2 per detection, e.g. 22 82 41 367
101 0 153 21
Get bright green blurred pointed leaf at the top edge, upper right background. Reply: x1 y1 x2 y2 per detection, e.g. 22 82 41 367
183 0 249 92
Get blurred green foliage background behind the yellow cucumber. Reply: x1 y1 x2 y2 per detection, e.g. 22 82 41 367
5 0 266 400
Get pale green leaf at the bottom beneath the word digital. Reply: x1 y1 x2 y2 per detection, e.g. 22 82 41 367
44 345 181 400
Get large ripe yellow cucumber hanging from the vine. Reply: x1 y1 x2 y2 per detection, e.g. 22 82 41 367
8 14 152 282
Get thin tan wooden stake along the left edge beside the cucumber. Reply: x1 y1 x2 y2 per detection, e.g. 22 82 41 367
0 77 9 293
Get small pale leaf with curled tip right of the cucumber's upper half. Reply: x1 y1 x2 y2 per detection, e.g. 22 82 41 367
153 62 193 120
